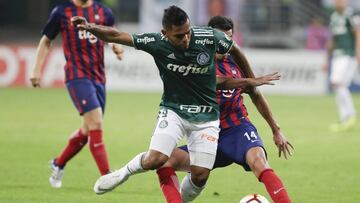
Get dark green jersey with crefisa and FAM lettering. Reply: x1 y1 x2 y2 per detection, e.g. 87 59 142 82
133 27 233 122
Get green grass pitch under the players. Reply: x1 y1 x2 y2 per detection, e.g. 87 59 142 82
0 88 360 203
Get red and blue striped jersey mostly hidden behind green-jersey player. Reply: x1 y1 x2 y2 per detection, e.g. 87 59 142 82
216 55 248 129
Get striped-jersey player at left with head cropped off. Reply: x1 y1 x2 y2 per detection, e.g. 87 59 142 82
30 0 123 188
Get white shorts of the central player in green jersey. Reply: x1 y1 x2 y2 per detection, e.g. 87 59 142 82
150 109 220 169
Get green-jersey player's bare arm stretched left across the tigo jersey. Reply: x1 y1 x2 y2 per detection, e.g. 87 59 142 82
71 16 134 47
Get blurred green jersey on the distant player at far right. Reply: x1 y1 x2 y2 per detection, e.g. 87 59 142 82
330 10 359 56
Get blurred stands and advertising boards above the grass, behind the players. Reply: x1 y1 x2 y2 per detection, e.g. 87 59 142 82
0 0 360 94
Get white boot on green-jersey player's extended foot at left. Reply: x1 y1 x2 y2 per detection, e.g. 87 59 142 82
94 166 130 195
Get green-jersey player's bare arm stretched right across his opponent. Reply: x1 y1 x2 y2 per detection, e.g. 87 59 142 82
216 72 280 90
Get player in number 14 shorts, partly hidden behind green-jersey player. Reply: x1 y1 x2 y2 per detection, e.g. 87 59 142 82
157 16 293 203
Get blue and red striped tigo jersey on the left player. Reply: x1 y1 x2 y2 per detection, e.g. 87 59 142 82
42 1 114 83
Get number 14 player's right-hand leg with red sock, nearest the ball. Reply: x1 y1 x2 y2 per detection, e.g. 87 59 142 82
246 147 291 203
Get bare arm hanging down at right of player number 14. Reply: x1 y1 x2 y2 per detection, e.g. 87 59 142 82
230 44 293 159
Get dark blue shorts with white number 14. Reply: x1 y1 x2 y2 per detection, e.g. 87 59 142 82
179 119 266 171
